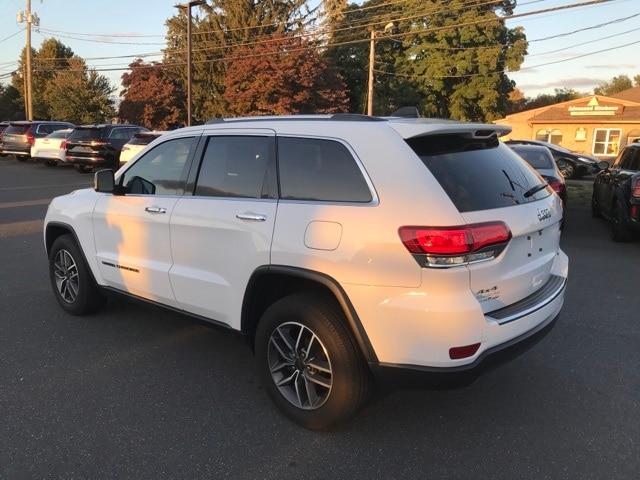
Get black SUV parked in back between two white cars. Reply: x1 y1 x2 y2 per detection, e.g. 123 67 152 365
66 123 149 173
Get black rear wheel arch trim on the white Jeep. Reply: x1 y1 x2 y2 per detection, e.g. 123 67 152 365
241 265 378 363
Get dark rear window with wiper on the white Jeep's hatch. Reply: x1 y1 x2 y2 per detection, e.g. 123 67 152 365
407 135 552 212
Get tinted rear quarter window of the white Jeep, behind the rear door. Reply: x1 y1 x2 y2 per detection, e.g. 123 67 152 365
278 137 373 202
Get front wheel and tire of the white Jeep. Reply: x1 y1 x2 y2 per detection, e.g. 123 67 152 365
49 235 106 315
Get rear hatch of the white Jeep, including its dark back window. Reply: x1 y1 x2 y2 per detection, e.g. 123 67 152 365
406 127 563 313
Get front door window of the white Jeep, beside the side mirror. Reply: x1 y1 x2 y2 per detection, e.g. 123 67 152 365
120 137 195 195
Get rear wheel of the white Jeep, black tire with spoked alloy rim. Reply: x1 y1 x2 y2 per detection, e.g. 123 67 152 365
255 293 371 430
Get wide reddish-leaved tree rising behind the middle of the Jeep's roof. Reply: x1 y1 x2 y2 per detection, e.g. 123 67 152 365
224 35 348 115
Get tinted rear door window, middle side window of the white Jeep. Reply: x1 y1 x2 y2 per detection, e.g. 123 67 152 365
195 135 270 198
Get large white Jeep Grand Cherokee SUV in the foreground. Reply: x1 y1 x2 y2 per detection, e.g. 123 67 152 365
44 115 568 429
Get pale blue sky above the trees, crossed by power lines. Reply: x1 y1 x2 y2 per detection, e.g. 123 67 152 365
0 0 640 98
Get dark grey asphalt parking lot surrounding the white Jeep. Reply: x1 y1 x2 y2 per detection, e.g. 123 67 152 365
0 158 640 480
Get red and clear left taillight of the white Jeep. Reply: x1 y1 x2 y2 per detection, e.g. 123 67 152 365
398 222 511 267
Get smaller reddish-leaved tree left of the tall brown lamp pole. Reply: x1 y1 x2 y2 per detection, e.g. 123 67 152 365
119 59 184 130
